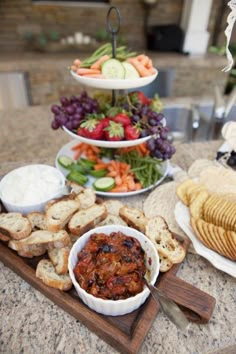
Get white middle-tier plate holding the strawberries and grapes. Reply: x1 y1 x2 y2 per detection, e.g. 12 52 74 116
62 127 151 149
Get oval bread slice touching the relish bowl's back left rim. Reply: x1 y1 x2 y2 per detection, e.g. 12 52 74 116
68 204 107 236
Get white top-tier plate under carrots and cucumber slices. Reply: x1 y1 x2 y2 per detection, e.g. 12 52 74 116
71 70 158 90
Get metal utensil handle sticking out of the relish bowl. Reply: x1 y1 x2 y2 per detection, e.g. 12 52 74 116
144 278 189 331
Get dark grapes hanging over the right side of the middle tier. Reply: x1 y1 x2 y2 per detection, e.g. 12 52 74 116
131 105 176 160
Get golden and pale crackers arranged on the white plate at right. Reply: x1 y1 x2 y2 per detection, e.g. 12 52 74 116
176 167 236 261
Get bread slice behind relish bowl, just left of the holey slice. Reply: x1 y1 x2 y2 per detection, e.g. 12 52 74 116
119 206 148 233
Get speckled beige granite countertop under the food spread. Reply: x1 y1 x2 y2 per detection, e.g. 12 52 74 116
0 106 236 354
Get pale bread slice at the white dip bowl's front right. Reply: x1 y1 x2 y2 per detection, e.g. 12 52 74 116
46 199 80 232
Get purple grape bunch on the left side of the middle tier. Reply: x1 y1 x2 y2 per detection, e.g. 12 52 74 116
51 91 99 130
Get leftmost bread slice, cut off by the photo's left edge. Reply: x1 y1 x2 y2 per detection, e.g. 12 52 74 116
0 213 31 240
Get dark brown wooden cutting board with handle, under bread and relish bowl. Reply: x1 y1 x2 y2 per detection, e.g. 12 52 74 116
0 235 215 354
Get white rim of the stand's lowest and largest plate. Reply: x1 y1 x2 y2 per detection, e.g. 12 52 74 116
55 140 170 197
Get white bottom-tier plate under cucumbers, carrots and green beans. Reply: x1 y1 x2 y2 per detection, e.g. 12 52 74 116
55 140 169 197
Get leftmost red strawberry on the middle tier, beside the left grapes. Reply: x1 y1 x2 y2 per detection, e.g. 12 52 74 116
77 118 103 140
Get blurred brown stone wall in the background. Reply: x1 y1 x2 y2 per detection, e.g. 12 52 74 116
0 0 225 52
